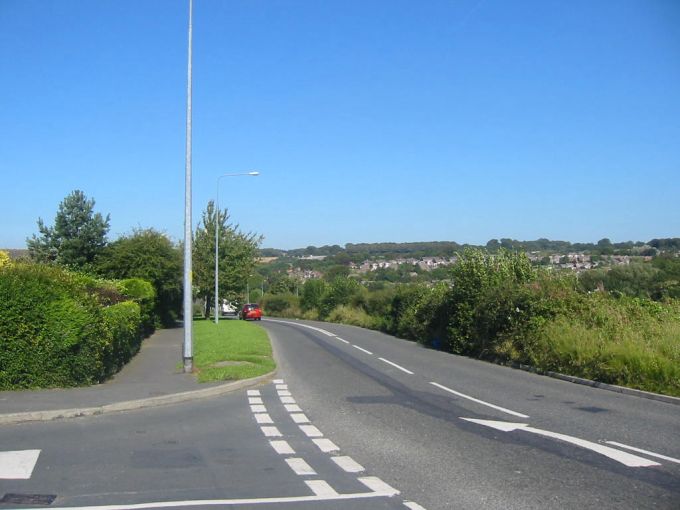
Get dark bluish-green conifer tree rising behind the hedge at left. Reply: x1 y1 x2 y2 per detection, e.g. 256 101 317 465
26 190 110 269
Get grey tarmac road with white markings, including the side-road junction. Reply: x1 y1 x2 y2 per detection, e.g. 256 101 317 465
0 320 680 510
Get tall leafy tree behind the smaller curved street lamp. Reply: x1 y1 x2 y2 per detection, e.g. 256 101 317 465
193 200 262 317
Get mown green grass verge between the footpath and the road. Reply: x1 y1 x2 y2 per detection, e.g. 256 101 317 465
194 320 276 382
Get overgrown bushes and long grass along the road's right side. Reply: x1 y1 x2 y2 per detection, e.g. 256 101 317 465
263 248 680 396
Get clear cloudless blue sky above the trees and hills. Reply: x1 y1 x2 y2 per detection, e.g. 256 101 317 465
0 0 680 248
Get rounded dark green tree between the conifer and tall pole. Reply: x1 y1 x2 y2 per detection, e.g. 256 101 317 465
96 228 182 326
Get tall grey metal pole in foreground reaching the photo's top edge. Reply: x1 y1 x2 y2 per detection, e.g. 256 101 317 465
182 0 194 373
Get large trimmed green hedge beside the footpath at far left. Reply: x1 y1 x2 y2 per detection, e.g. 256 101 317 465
0 263 145 390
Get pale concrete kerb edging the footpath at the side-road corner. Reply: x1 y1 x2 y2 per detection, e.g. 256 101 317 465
0 370 276 425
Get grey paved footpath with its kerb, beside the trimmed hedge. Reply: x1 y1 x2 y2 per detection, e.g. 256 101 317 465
0 328 271 425
